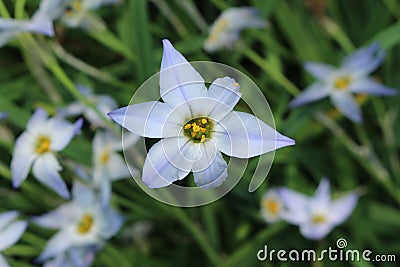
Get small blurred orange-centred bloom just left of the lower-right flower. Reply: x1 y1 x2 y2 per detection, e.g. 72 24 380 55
261 189 283 223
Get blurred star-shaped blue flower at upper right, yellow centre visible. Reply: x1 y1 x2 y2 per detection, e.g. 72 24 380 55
290 43 397 122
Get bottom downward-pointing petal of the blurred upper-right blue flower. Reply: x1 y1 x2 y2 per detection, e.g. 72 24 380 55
331 90 362 123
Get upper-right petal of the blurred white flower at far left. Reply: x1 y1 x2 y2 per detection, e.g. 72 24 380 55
48 117 83 151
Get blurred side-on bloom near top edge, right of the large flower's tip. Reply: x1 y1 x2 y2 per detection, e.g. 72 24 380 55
204 7 267 52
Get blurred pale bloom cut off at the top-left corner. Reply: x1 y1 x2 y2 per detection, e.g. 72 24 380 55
0 0 65 47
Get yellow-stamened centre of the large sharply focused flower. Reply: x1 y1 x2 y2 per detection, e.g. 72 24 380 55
183 117 214 143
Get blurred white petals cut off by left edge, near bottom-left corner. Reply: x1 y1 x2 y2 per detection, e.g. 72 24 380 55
0 211 28 267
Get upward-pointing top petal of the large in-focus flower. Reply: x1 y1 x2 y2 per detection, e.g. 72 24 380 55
160 39 207 107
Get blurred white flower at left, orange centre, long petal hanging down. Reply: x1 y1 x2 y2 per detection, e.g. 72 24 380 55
11 109 82 198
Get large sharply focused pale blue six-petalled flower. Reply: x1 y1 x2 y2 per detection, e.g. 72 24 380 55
109 40 294 188
